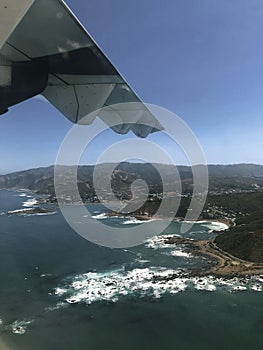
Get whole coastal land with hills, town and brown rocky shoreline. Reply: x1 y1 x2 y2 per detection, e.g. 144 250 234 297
0 162 263 274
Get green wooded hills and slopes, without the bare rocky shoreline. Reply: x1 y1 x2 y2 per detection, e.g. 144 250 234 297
0 162 263 262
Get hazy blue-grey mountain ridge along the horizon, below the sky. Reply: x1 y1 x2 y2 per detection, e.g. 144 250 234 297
0 162 263 198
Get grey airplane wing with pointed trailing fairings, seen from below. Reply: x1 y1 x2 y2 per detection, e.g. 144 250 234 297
0 0 163 137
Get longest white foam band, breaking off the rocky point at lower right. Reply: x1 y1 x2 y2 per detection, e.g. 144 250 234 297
53 267 263 304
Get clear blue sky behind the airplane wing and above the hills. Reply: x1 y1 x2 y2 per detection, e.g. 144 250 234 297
0 0 263 173
